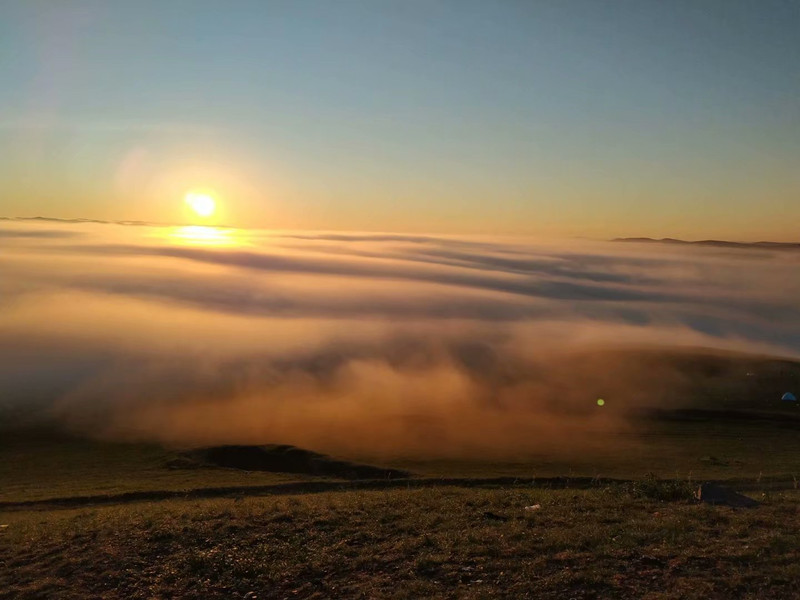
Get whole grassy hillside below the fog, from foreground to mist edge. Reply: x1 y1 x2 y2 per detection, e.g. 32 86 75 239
0 422 800 599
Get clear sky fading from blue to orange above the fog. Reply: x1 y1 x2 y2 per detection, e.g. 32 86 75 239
0 0 800 240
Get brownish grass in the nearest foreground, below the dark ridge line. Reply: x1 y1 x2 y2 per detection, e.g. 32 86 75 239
0 486 800 600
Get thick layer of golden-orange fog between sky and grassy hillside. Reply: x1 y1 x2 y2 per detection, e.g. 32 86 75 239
0 220 800 456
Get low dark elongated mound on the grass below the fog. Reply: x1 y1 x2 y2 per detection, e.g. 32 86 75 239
186 445 411 479
